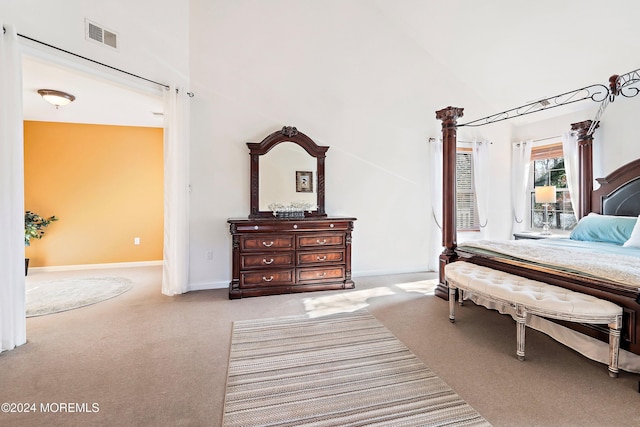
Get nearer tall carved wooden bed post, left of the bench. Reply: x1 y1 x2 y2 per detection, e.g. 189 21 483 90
435 107 463 300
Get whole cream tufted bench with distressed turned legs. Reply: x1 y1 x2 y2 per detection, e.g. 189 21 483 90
445 261 622 377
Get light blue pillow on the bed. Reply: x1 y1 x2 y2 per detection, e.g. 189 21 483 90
569 213 638 245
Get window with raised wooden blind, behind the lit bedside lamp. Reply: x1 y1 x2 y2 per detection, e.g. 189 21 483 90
529 143 576 230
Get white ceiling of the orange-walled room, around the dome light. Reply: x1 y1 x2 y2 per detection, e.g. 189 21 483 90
22 55 164 127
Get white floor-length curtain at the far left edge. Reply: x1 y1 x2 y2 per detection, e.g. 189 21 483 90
0 24 27 351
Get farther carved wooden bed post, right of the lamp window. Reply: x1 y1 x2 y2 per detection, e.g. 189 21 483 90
571 120 598 219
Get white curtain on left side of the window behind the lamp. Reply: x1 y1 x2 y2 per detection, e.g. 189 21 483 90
511 141 533 233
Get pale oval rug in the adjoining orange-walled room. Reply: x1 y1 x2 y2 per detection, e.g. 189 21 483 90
26 277 133 317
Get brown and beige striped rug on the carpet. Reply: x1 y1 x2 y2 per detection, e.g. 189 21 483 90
223 311 490 427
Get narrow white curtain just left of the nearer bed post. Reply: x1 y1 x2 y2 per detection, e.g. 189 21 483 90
429 138 443 271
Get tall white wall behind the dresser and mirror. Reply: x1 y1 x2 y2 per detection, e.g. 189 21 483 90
190 0 506 287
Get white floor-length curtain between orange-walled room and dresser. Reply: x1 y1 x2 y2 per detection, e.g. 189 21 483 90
162 86 189 295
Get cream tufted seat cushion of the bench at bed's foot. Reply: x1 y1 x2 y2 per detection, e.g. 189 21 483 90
445 262 622 317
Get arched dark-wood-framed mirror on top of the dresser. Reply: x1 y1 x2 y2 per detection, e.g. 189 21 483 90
247 126 329 218
